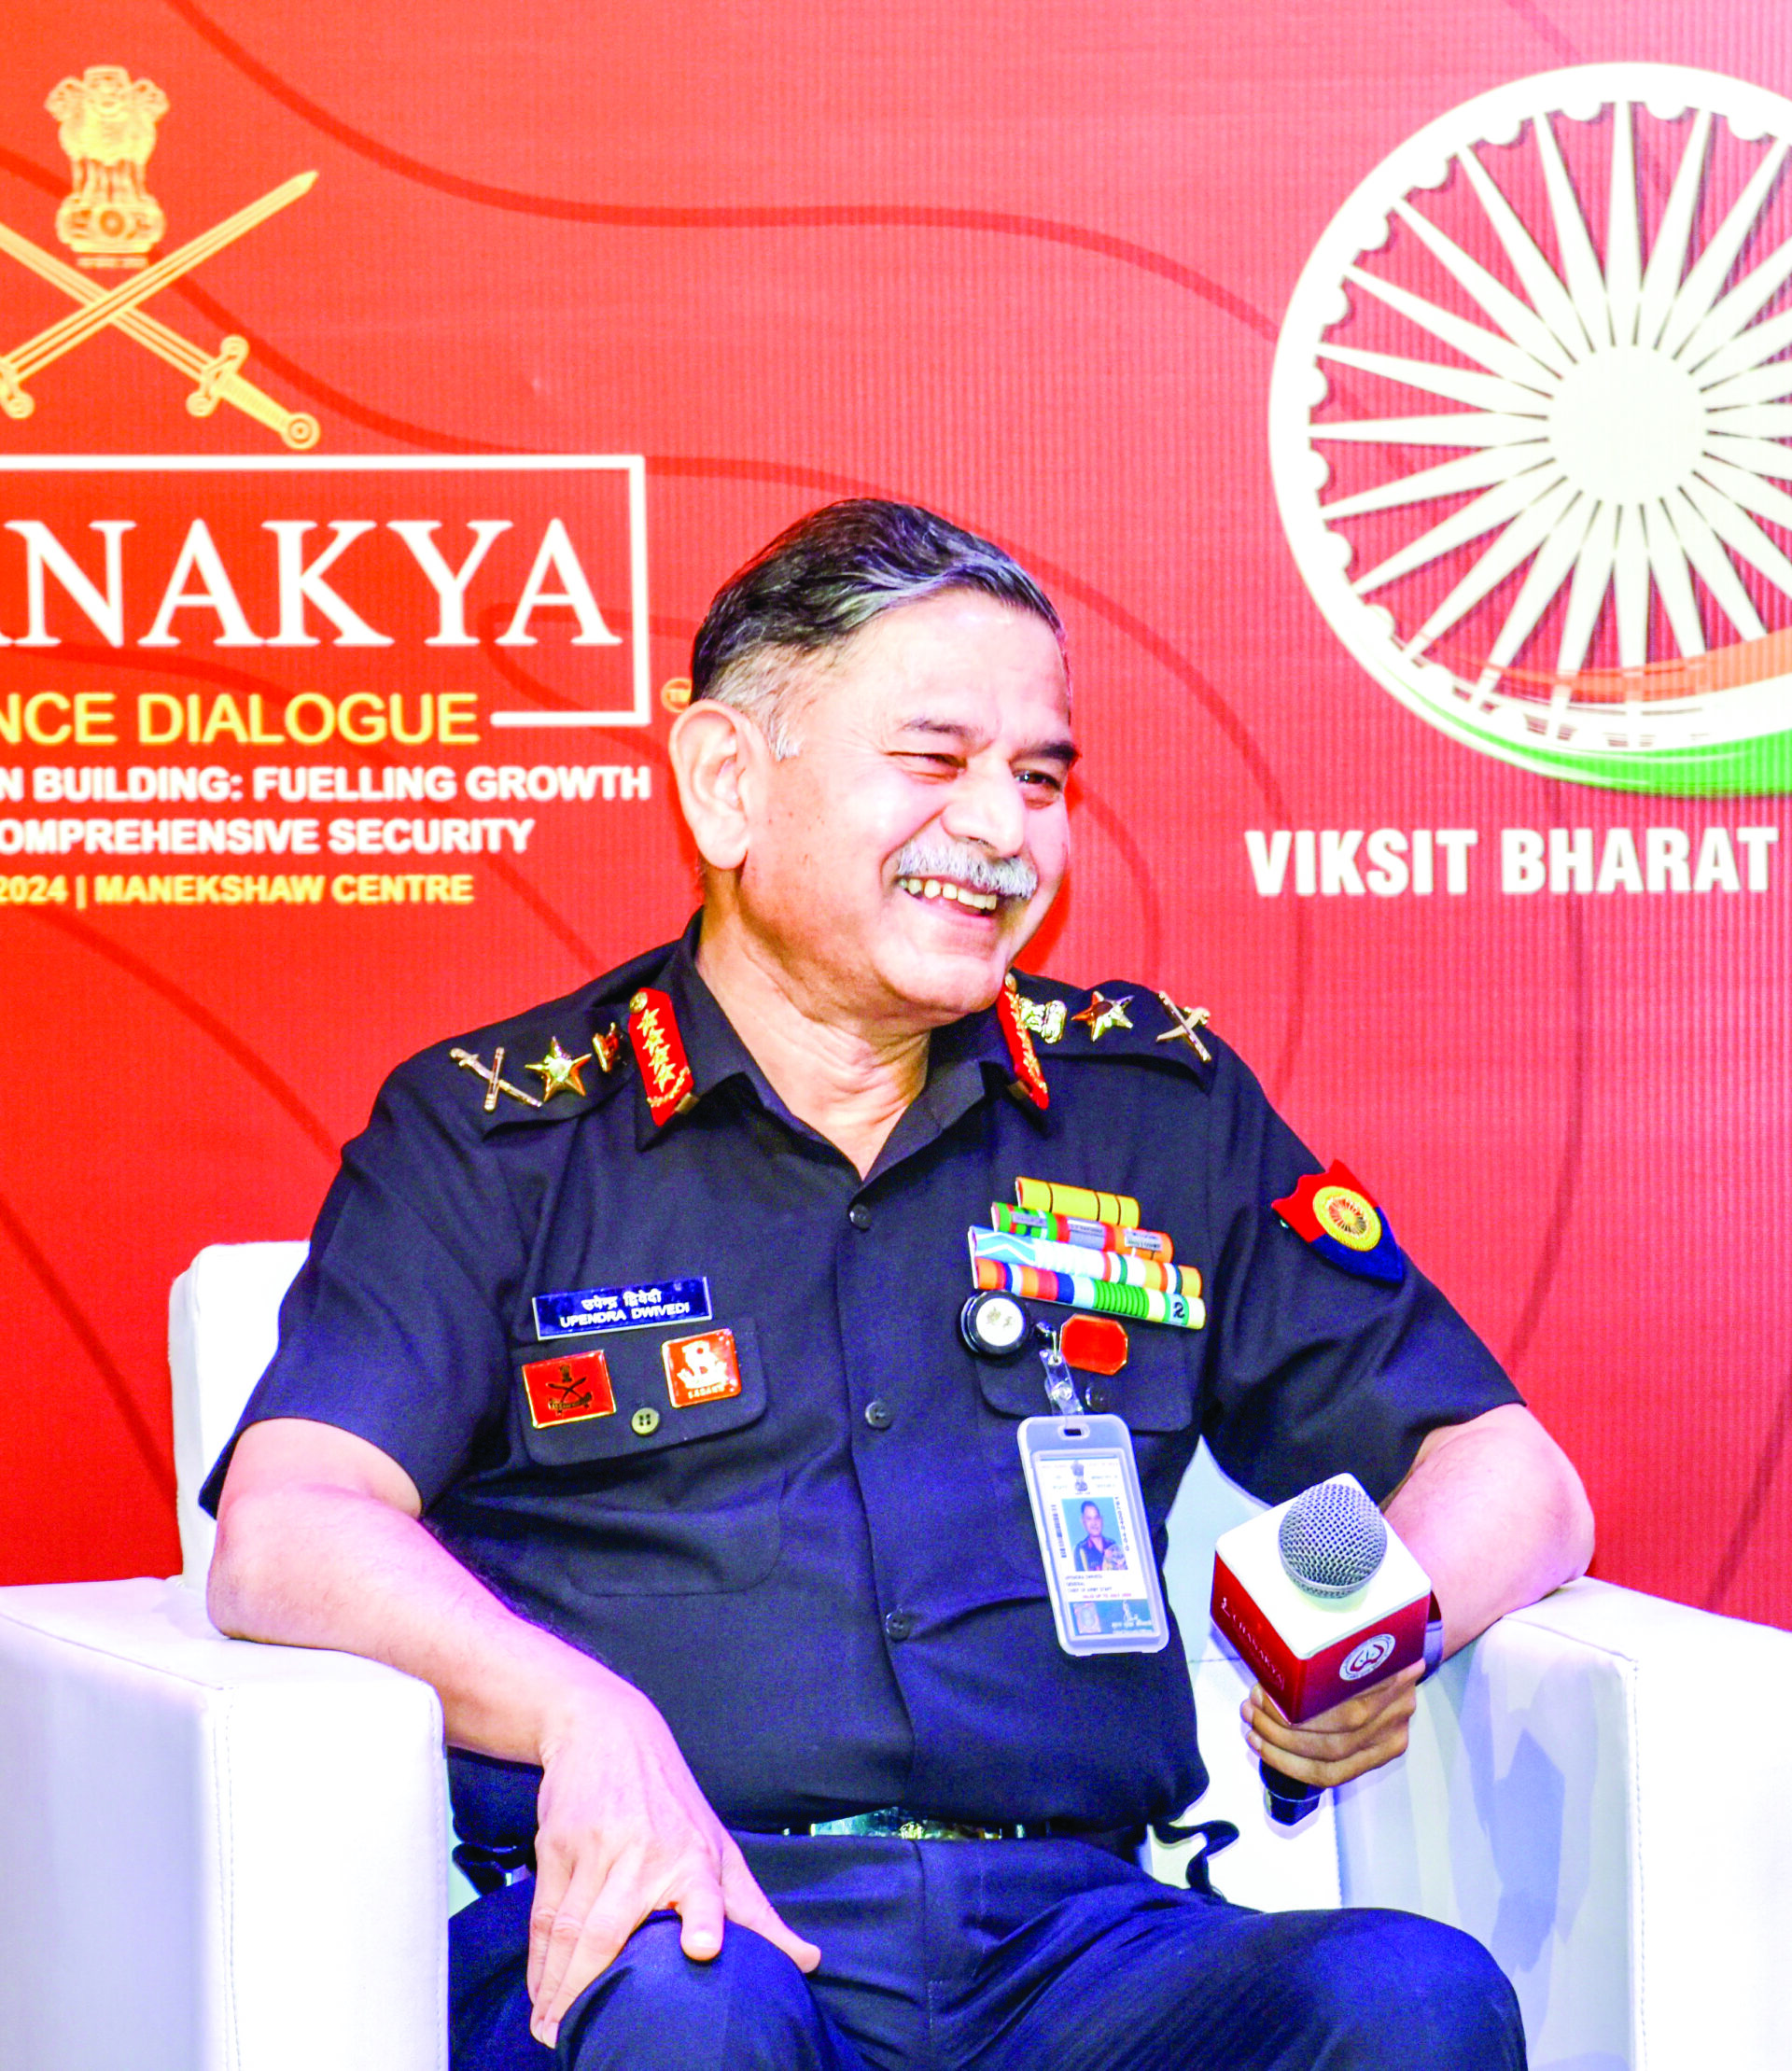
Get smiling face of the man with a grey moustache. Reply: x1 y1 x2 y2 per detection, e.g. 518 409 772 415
735 590 1075 1031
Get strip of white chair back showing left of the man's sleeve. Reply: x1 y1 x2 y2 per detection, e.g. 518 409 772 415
168 1245 307 1590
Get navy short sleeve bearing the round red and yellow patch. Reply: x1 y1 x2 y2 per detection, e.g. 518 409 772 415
1204 1043 1522 1502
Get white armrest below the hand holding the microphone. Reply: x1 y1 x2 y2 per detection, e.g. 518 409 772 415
1337 1582 1792 2071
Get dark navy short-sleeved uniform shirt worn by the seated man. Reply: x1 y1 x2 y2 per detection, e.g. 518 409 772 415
205 926 1517 1828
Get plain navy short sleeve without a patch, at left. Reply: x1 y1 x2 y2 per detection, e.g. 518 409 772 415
199 1058 525 1512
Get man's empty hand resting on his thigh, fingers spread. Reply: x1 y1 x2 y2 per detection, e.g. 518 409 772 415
528 1686 820 2046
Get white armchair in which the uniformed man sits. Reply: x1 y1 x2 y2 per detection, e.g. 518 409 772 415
0 1245 1792 2071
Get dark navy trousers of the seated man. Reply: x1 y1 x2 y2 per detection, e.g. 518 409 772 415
450 1835 1525 2071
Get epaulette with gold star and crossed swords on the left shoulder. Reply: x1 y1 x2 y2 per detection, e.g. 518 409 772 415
443 951 667 1128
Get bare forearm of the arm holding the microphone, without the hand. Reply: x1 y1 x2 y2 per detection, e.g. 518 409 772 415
1386 1404 1593 1653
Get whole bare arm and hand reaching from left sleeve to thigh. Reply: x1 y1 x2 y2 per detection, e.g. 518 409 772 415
209 1419 820 2042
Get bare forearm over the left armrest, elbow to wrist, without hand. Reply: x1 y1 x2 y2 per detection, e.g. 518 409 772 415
207 1485 647 1762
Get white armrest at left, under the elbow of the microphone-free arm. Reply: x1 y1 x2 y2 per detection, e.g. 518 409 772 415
0 1580 447 2071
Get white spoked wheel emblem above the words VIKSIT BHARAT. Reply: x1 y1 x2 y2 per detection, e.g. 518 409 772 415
1270 64 1792 793
